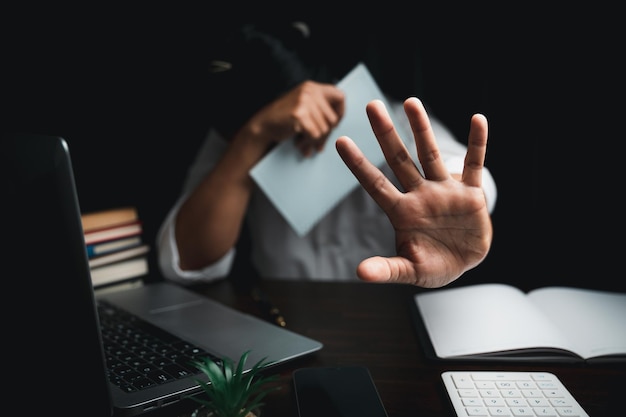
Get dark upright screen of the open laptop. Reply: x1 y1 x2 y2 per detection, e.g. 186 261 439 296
0 134 112 417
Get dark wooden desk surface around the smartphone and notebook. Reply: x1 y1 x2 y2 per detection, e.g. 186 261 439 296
151 281 626 417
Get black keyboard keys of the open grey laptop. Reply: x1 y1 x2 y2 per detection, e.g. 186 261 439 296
98 300 217 392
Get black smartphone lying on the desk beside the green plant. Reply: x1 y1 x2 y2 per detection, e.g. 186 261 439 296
293 366 388 417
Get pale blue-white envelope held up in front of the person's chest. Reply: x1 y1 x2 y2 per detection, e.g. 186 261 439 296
250 63 406 236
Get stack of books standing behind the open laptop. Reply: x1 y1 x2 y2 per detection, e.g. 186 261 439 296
81 207 150 288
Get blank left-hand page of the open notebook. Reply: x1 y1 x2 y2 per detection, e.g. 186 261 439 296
415 284 578 358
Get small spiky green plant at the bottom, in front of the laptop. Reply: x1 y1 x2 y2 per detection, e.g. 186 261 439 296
191 351 280 417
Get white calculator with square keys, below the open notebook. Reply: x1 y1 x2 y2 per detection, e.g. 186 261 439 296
441 371 589 417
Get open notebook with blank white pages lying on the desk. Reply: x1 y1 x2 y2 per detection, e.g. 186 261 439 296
411 283 626 364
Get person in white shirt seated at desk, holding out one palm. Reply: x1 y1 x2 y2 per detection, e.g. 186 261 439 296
157 22 496 287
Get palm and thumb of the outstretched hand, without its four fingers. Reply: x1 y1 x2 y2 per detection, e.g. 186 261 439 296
380 178 492 287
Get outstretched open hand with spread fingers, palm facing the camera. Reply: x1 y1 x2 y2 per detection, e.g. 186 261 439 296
336 97 493 288
